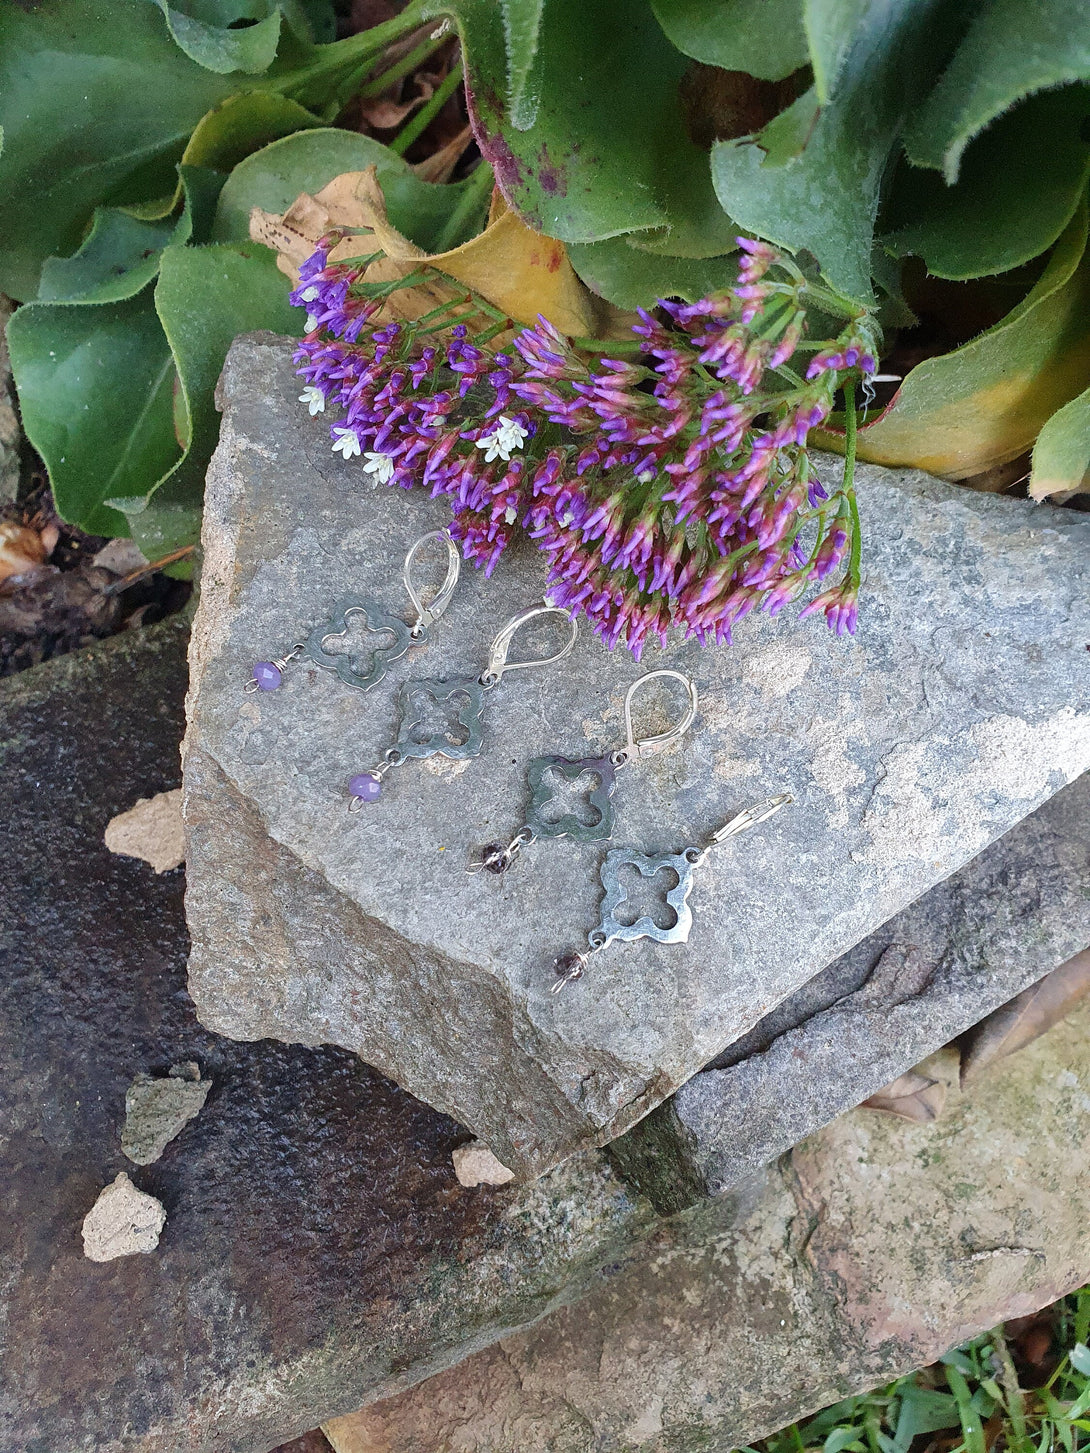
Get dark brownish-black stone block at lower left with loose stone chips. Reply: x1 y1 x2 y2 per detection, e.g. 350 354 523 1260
0 620 648 1453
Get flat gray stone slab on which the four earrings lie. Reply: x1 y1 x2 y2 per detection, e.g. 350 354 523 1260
185 336 1090 1175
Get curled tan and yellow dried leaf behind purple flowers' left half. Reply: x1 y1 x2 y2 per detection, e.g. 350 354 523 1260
250 167 631 337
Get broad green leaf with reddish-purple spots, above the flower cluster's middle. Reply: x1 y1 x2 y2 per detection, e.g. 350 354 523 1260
427 0 731 256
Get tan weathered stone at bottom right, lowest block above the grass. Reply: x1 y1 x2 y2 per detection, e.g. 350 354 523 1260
326 1005 1090 1453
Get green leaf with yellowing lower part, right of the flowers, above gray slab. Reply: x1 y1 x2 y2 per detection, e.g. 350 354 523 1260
848 202 1090 479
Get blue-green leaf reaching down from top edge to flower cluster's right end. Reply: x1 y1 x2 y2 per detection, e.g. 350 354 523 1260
712 0 946 302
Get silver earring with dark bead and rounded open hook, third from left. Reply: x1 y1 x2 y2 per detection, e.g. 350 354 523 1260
467 670 698 873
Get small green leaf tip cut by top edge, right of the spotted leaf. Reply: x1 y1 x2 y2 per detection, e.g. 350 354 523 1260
653 0 810 81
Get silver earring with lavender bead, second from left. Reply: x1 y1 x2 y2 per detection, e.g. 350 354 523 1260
349 606 578 812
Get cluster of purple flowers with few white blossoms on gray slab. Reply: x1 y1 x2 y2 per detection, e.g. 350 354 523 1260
292 238 876 658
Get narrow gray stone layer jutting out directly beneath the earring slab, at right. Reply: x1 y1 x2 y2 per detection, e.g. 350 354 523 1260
610 774 1090 1212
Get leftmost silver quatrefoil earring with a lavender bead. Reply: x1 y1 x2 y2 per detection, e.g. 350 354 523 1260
244 530 462 692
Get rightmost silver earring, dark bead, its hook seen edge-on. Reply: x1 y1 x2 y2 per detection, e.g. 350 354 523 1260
552 792 792 994
